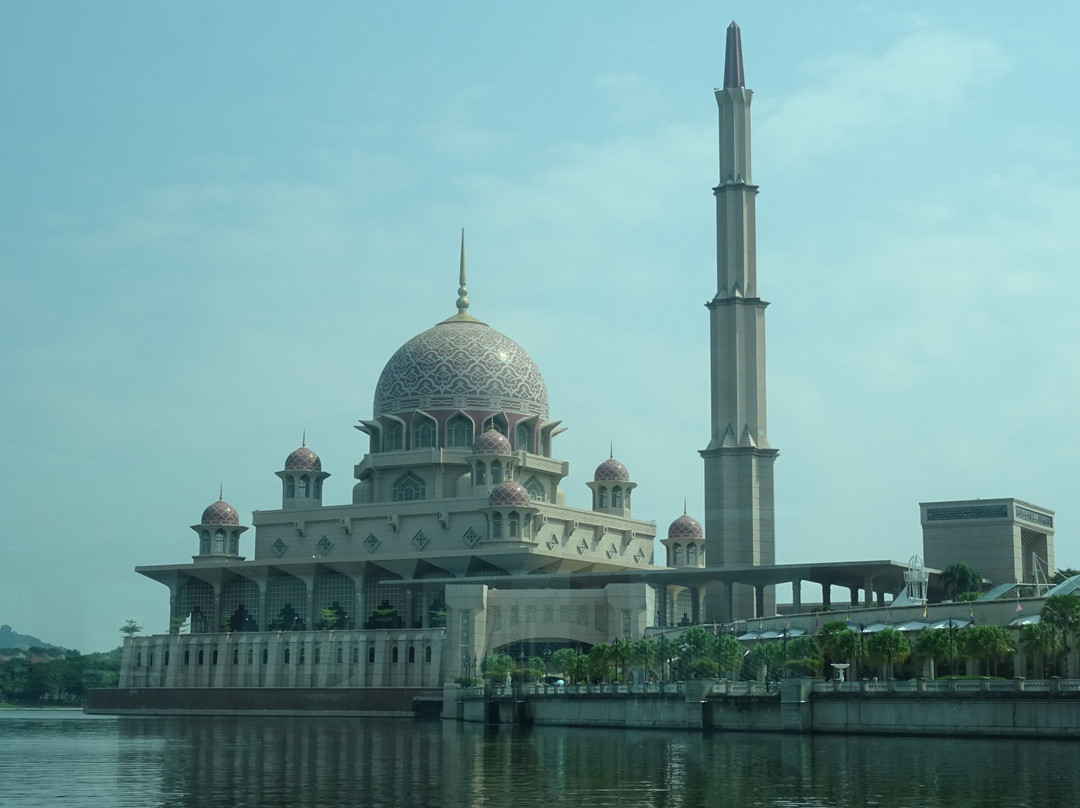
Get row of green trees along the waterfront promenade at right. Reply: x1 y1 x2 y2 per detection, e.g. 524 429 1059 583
481 594 1080 684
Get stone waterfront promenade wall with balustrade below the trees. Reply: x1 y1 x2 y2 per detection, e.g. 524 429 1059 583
453 678 1080 739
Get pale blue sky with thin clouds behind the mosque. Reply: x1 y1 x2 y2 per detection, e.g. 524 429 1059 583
0 0 1080 652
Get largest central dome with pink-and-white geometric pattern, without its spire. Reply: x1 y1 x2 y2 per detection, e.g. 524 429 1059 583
374 319 548 419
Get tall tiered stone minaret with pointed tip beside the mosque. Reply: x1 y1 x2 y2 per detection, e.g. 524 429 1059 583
701 23 778 621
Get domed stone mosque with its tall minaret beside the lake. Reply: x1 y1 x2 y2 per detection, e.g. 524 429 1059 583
113 23 1052 688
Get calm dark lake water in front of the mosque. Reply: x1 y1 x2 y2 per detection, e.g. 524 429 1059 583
0 710 1080 808
